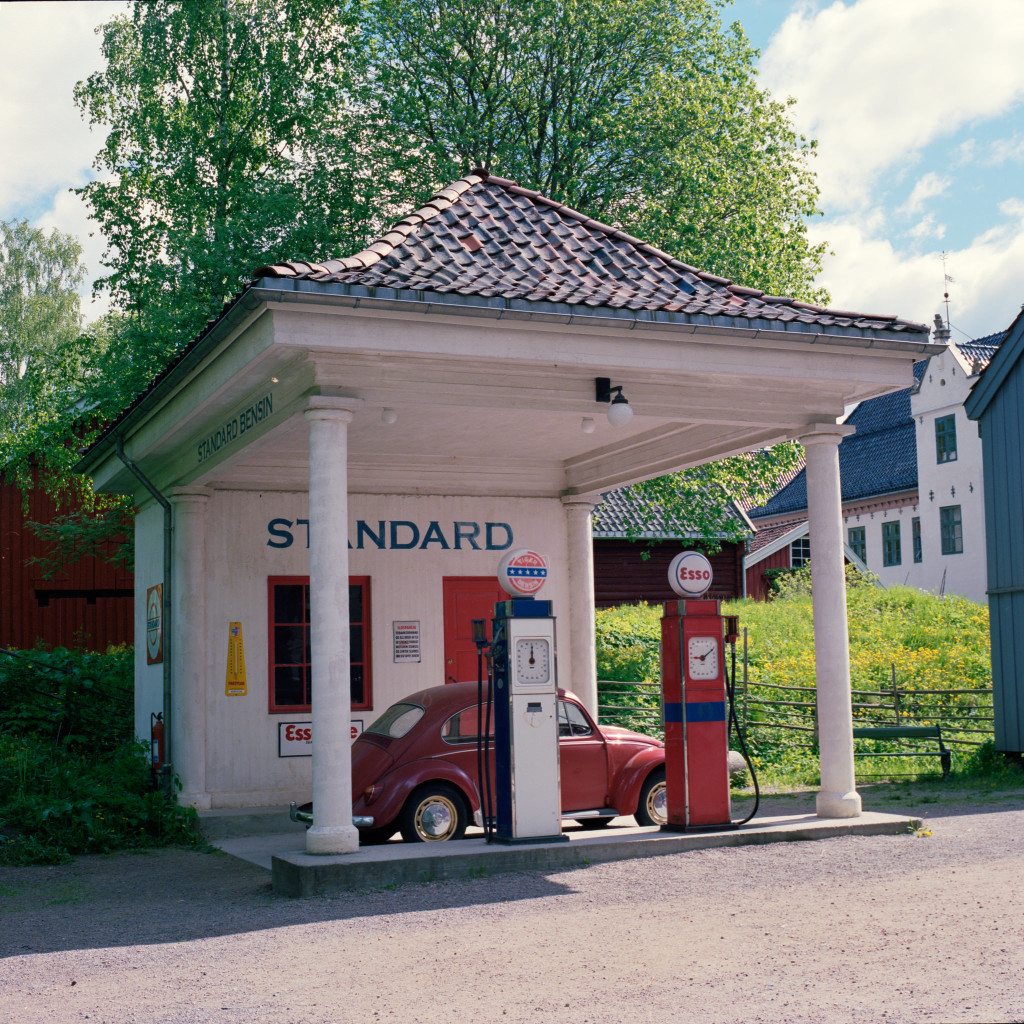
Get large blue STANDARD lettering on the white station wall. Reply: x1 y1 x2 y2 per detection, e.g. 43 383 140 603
266 518 513 551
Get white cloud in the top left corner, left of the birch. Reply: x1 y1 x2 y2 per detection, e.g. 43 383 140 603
0 2 126 219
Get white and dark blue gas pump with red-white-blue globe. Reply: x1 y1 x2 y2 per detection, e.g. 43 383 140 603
490 549 567 844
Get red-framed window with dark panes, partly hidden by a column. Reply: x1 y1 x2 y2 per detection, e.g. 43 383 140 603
267 577 373 713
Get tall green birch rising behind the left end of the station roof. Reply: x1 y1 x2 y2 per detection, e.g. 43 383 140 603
75 0 368 356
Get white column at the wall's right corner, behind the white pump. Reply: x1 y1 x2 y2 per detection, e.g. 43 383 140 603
561 498 597 719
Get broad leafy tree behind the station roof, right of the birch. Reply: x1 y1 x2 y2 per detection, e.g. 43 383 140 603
365 0 824 299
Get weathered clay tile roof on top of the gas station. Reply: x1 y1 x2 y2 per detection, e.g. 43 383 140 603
253 170 928 340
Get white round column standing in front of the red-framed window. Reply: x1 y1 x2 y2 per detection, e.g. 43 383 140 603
305 397 361 853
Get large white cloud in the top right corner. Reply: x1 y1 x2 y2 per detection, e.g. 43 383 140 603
761 0 1024 212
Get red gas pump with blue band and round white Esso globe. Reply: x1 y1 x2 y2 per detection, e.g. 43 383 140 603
662 551 734 831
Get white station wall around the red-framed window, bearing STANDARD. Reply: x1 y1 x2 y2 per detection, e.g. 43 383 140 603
136 490 572 806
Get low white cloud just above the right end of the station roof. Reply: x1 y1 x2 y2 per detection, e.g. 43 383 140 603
810 199 1024 339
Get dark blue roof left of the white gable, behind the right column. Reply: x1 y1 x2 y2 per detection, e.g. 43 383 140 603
751 359 928 519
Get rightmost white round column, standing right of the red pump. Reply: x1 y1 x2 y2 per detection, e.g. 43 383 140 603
800 423 860 818
